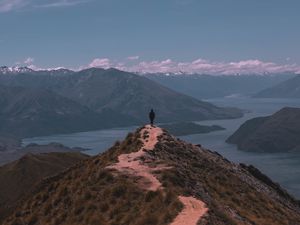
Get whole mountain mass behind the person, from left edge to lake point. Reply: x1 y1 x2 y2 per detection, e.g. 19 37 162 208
0 67 242 137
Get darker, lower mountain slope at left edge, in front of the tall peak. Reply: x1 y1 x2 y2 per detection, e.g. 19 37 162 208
0 86 132 137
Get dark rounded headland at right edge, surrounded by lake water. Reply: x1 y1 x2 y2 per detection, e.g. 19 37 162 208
227 108 300 152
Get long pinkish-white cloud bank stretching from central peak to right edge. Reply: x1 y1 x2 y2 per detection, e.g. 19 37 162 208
88 58 300 75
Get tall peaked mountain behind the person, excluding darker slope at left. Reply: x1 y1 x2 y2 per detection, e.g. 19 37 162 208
0 68 242 128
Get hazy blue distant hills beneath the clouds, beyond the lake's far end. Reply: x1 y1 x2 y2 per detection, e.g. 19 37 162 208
144 74 295 99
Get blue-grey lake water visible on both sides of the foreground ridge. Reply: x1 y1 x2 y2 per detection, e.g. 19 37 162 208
23 97 300 199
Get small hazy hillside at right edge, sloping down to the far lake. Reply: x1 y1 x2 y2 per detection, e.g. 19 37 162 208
254 75 300 98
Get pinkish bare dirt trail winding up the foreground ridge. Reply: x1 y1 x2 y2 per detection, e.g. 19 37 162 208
107 125 208 225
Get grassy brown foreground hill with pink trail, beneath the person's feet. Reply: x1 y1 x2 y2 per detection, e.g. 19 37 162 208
3 125 300 225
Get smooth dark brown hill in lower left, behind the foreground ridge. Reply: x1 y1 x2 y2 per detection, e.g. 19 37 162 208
0 153 88 223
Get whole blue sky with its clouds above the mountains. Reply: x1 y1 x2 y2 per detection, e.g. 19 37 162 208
0 0 300 73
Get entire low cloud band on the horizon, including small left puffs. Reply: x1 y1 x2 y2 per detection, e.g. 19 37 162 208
15 56 300 75
